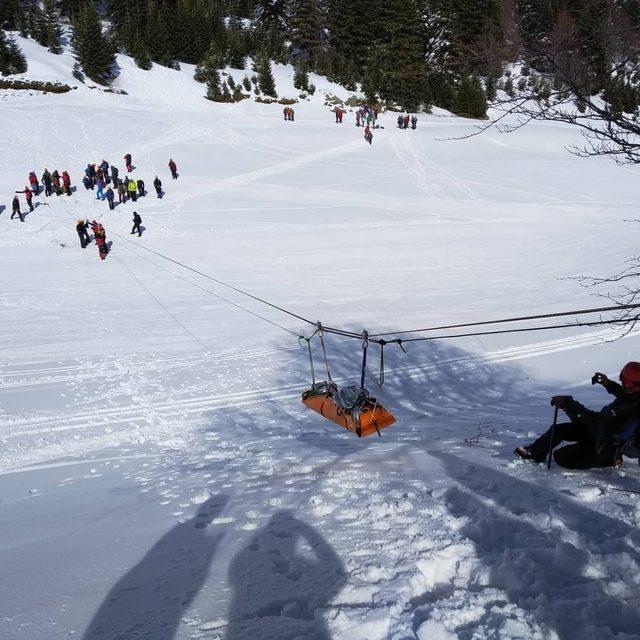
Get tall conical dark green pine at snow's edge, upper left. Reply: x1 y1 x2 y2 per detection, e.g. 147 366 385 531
72 3 116 84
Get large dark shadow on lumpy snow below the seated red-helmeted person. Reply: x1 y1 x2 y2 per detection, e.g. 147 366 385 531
427 453 640 640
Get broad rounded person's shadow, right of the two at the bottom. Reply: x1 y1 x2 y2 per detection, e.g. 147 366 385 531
225 511 347 640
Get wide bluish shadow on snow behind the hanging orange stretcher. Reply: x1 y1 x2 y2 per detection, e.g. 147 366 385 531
276 337 557 449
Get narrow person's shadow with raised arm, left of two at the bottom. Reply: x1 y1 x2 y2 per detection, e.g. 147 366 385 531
83 495 228 640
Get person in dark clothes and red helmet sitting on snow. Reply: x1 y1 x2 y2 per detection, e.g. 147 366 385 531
514 362 640 469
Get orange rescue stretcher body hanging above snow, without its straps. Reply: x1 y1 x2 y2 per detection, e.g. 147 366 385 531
302 382 396 438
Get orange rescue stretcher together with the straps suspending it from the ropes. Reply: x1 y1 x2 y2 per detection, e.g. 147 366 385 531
302 323 396 438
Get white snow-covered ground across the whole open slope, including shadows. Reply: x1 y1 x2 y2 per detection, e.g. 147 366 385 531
0 40 640 640
